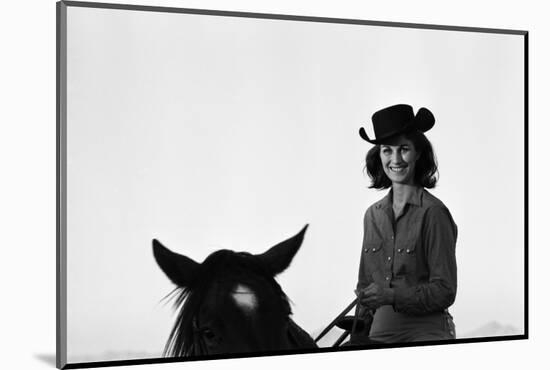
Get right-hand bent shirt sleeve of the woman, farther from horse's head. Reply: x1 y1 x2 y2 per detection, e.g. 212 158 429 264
394 206 457 315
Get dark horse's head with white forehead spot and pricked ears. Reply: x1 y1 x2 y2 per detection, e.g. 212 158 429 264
153 225 317 357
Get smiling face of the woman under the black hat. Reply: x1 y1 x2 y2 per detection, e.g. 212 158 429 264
380 136 420 185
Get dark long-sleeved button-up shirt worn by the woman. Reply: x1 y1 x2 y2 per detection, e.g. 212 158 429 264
357 188 457 315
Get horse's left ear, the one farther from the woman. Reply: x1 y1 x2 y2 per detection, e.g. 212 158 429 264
153 239 200 287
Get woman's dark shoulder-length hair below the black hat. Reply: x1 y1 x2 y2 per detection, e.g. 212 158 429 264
365 130 438 189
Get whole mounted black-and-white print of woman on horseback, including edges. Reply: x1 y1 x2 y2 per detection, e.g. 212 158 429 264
57 1 528 368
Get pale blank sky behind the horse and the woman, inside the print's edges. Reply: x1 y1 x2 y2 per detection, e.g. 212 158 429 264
67 7 524 362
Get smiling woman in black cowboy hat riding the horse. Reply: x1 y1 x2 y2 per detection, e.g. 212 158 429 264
351 104 457 344
